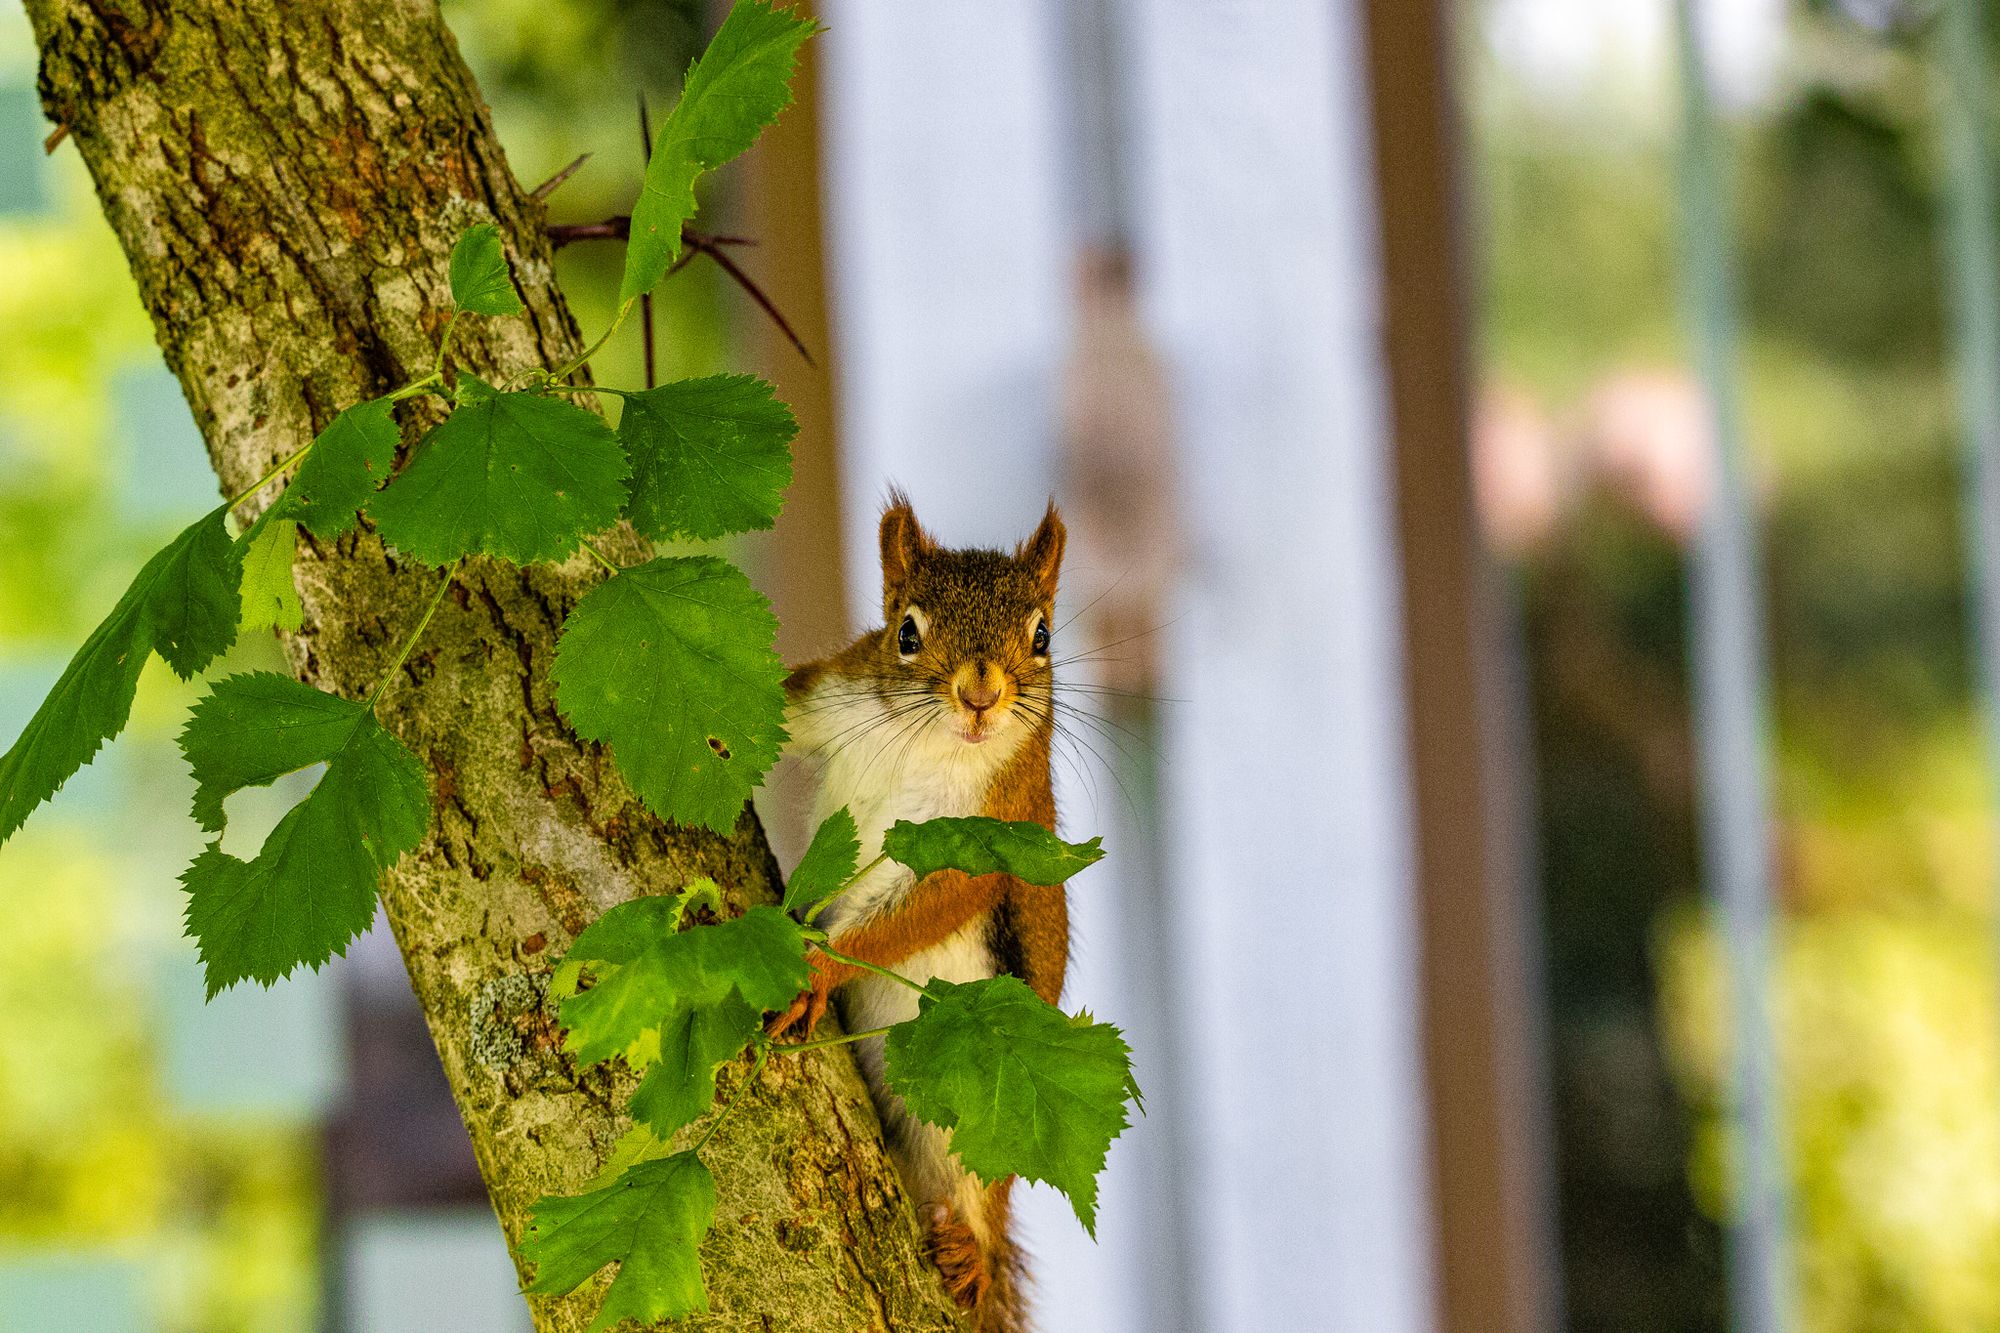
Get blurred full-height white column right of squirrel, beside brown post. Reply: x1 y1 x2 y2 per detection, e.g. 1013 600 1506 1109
1132 0 1440 1333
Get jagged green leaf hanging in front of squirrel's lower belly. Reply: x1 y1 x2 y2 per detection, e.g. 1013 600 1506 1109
884 977 1138 1235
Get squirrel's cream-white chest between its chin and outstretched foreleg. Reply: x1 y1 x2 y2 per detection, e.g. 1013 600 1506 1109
786 677 1008 931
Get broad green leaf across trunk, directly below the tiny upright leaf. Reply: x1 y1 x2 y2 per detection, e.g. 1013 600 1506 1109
368 374 628 564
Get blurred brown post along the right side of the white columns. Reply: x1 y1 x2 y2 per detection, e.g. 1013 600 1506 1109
1366 0 1556 1333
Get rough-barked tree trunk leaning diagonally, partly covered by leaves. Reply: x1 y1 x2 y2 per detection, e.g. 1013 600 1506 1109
28 0 958 1331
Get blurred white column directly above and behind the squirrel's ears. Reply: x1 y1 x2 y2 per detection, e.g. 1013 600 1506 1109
820 0 1070 624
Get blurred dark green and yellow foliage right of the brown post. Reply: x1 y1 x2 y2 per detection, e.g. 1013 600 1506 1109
1474 4 2000 1333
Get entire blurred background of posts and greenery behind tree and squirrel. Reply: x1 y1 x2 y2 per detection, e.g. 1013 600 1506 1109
0 0 2000 1333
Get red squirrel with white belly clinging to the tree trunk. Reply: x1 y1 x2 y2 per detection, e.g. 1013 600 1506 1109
770 492 1070 1333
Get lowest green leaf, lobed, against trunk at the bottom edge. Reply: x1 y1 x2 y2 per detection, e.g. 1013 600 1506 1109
520 1153 716 1333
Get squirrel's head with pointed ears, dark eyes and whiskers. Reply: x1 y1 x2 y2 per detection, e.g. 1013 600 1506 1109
874 492 1064 745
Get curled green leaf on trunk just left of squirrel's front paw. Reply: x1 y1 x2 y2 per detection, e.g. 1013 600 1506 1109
562 899 810 1065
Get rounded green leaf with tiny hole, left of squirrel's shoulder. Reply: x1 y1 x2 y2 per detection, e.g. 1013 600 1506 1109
550 556 786 833
